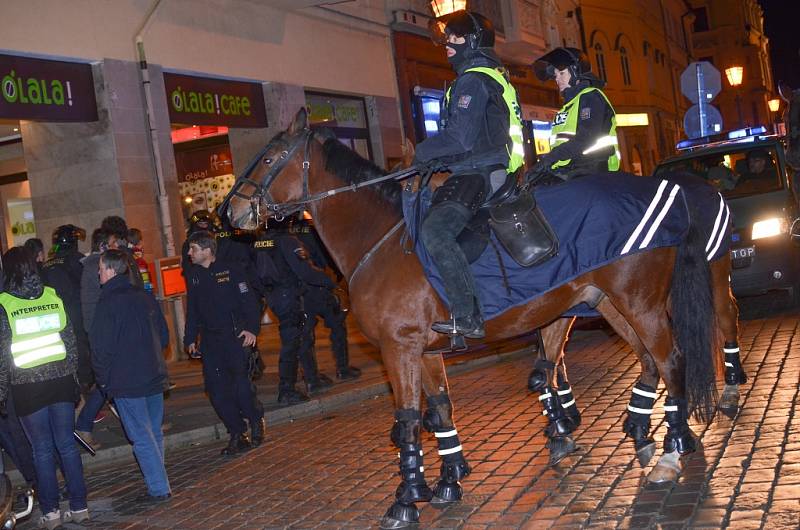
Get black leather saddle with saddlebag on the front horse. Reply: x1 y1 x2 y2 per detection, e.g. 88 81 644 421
457 173 558 267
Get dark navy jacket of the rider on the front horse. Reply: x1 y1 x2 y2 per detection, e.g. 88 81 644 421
415 54 511 173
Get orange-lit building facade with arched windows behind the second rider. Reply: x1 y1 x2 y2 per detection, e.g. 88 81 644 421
581 0 692 175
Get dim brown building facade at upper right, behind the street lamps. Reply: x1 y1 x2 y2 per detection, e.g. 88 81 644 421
690 0 776 134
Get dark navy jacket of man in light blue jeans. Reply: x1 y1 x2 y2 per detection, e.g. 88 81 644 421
89 275 169 397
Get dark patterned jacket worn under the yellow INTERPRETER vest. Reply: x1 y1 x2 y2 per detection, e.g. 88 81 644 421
0 275 78 402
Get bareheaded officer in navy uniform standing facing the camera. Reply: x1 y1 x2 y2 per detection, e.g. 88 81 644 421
184 231 265 455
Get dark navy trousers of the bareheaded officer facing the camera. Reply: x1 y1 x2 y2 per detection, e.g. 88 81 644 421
202 331 264 435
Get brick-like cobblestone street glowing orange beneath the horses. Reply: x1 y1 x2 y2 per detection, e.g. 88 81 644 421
14 315 800 530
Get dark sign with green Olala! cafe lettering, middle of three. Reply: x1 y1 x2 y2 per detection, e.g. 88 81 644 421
164 72 267 127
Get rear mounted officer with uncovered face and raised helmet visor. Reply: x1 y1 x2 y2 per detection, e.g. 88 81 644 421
526 48 620 182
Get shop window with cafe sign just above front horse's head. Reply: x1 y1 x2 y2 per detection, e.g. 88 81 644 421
306 92 372 160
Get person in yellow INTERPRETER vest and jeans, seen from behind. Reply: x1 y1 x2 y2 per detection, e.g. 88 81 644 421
0 247 89 530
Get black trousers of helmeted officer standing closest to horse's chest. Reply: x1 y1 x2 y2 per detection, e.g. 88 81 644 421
302 286 350 370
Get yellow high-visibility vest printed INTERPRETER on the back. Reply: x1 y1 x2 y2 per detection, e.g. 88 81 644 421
0 287 67 368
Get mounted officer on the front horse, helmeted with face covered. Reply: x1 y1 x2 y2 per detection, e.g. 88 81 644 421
415 11 524 338
